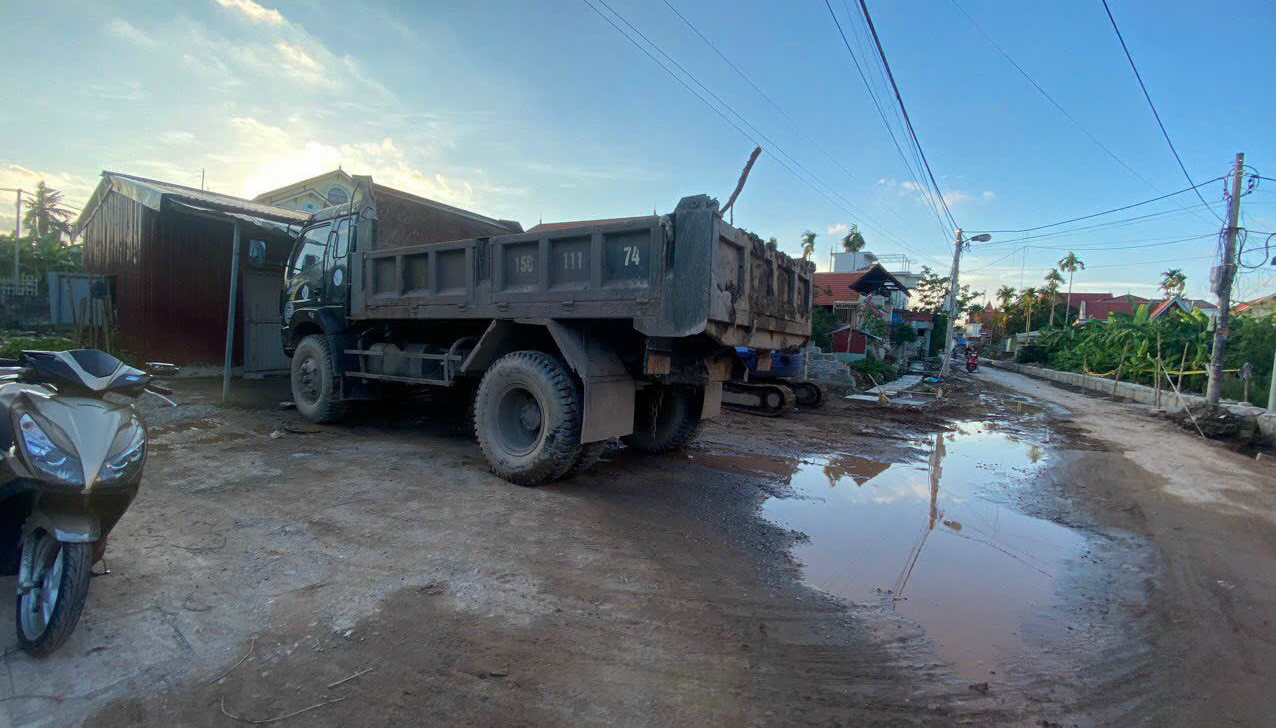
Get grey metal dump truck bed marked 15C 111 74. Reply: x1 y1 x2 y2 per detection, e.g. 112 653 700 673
351 195 814 349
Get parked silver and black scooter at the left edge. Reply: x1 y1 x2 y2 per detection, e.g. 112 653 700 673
0 349 177 657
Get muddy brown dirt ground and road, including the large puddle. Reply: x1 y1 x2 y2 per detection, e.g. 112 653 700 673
0 368 1276 728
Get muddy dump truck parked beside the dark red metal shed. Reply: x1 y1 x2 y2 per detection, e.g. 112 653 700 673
281 177 814 486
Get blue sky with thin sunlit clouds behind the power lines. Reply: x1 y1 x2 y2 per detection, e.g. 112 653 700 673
0 0 1276 297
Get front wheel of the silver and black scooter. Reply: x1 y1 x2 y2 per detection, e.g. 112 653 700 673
17 529 93 657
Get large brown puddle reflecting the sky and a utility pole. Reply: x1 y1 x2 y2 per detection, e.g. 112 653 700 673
763 420 1085 680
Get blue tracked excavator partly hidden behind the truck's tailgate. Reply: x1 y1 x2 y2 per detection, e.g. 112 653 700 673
722 347 828 417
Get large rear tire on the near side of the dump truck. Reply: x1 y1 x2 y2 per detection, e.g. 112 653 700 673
475 351 581 486
